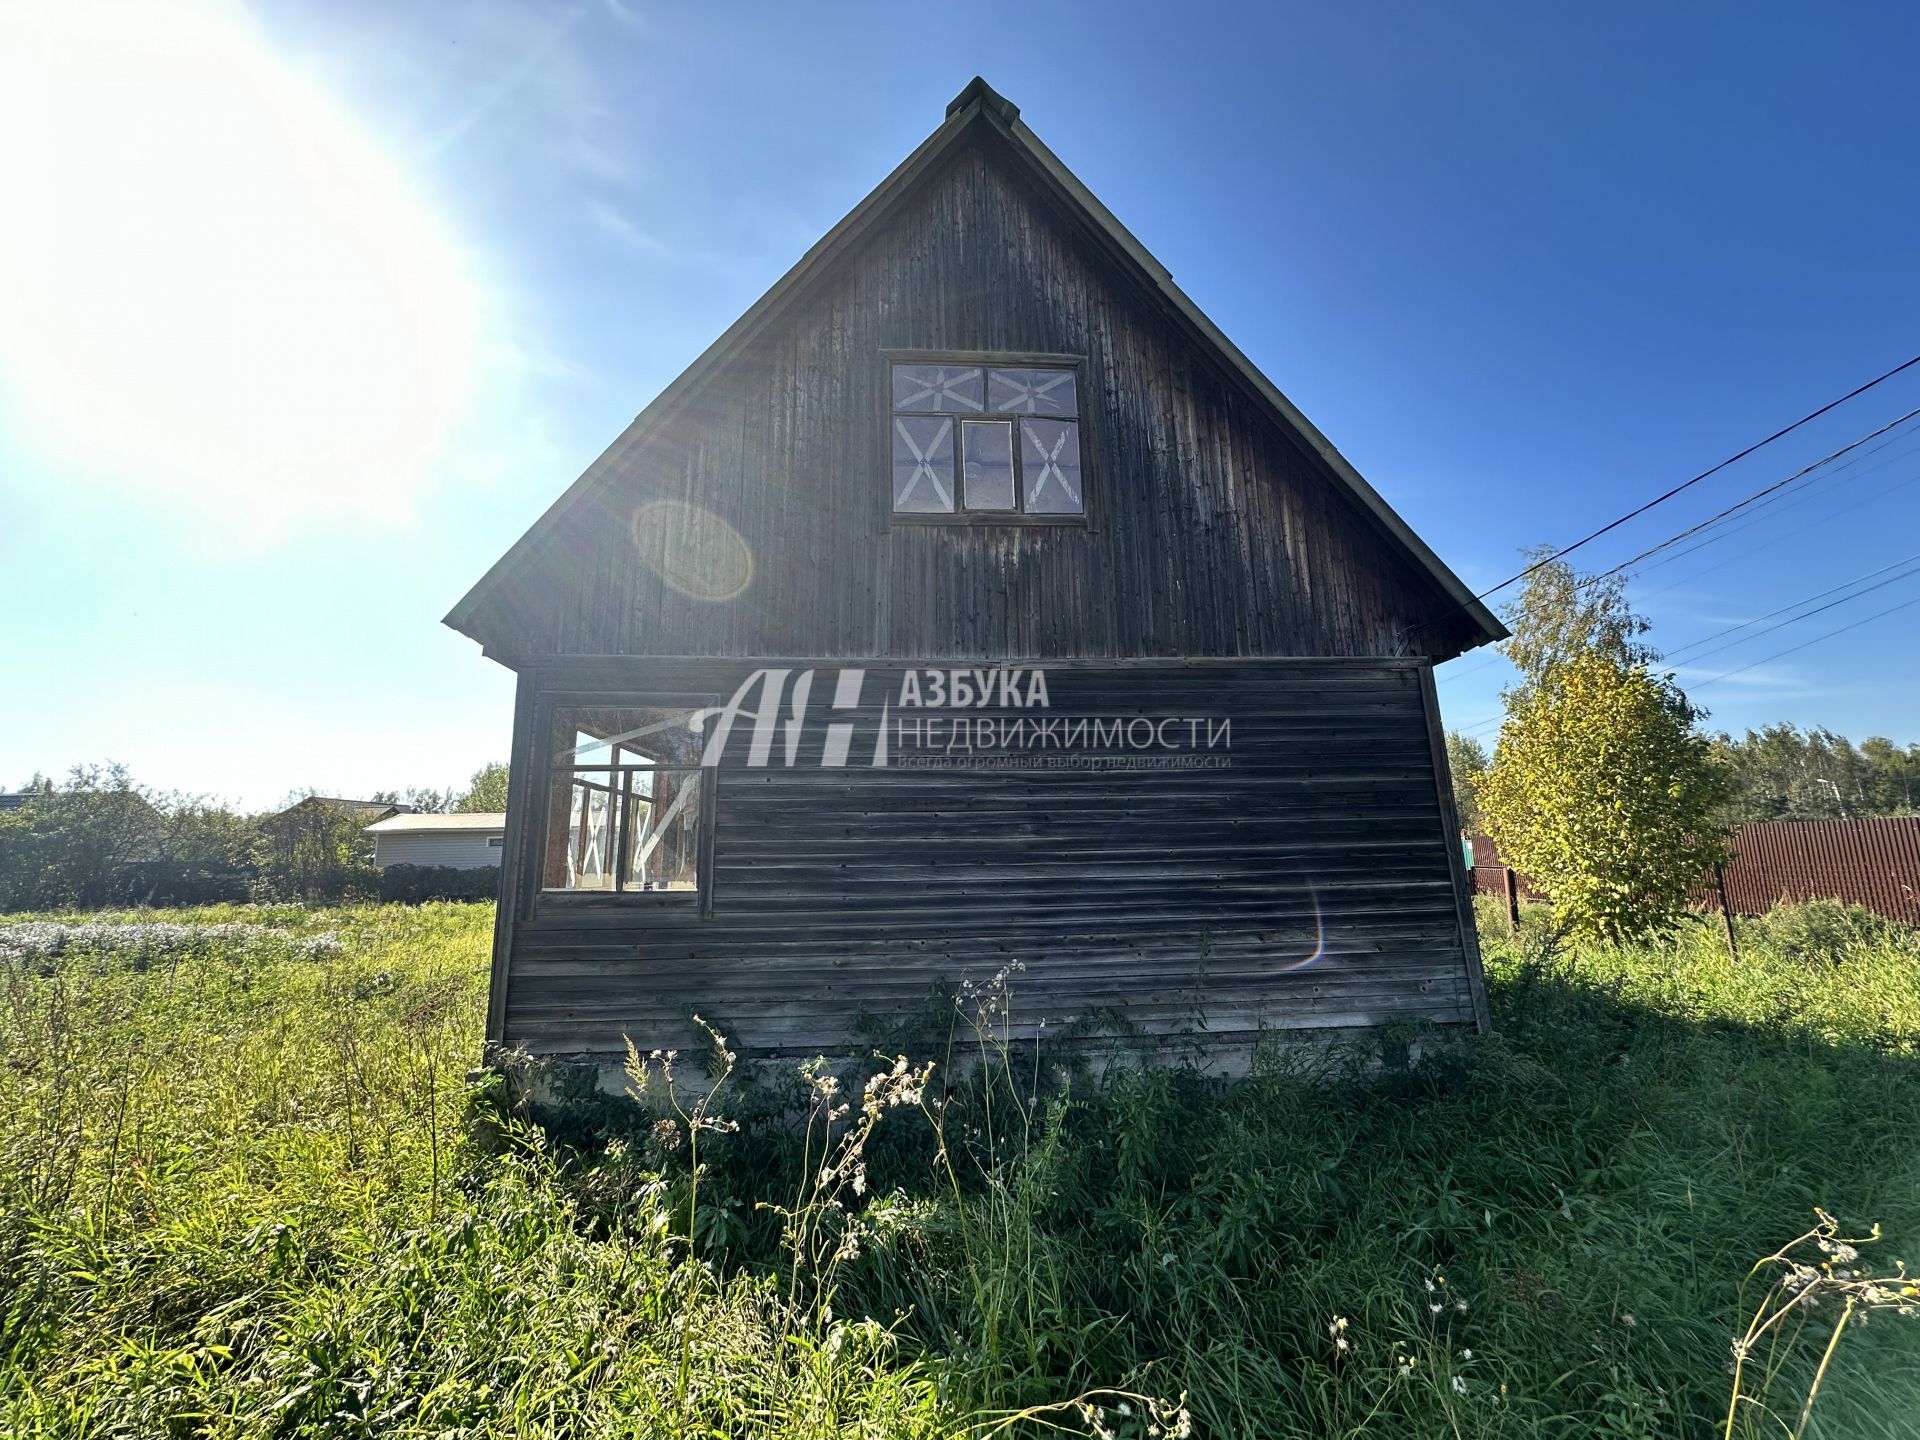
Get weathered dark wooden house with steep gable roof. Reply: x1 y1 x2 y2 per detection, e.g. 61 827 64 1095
447 79 1505 1062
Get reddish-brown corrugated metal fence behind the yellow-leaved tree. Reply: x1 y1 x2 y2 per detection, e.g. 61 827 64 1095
1473 818 1920 925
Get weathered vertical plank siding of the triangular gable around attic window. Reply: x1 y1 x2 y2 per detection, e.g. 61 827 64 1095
474 136 1473 662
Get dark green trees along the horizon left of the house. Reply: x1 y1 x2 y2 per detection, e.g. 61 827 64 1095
0 764 507 912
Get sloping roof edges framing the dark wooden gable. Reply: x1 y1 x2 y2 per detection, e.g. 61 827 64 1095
442 75 1507 649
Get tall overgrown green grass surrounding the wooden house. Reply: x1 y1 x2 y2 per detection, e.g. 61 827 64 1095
0 906 1920 1438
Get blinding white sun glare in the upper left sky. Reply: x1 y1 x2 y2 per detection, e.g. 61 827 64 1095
0 0 482 538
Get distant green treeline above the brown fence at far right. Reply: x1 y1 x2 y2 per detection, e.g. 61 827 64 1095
1715 726 1920 826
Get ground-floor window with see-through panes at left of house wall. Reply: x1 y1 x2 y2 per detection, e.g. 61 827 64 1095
541 705 710 895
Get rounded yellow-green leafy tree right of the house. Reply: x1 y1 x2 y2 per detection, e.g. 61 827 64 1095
1478 651 1726 939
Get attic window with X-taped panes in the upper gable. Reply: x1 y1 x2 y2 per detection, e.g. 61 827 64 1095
891 357 1087 524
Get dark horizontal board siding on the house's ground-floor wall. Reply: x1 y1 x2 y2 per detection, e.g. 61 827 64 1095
495 660 1476 1054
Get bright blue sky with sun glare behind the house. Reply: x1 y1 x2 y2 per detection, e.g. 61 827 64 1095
0 0 1920 804
